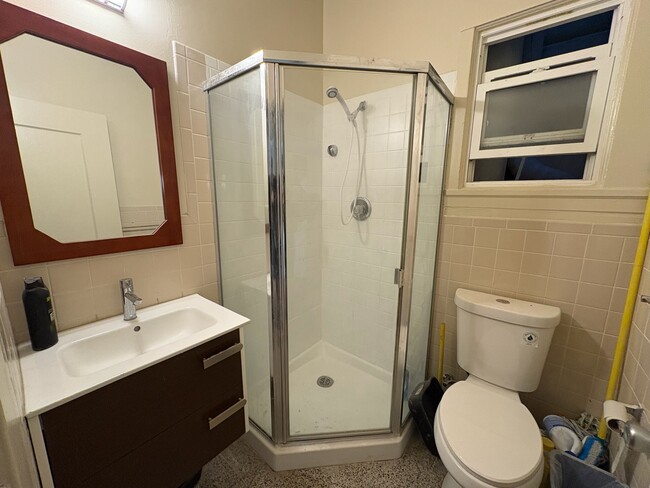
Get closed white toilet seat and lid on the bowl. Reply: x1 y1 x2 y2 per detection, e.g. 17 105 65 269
436 376 543 487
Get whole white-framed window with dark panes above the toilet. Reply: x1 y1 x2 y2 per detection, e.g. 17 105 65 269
468 0 623 182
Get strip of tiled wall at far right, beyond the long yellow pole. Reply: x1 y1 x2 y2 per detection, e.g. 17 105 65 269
612 241 650 488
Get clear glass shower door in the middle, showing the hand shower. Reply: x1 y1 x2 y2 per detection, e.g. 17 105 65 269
281 67 413 438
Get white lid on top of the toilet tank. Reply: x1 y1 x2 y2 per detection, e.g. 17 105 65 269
454 288 561 329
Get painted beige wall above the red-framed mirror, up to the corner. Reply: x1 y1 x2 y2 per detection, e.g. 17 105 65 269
9 0 323 64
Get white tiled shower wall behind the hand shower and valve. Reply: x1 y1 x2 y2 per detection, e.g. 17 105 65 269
322 83 412 371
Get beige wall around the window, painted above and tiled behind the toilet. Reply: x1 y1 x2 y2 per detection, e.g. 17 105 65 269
323 0 650 417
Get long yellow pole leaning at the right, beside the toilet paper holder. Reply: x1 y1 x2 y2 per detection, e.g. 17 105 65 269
598 195 650 439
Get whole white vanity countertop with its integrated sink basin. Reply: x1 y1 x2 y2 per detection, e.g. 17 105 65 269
18 295 248 417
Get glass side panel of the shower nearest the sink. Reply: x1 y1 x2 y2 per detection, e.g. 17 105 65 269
209 69 272 436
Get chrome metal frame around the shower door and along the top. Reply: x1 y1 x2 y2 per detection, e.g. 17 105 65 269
204 51 453 444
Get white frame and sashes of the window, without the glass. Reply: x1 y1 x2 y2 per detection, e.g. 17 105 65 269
465 0 632 186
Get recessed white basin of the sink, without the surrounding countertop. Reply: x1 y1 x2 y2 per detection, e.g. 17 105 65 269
59 308 215 376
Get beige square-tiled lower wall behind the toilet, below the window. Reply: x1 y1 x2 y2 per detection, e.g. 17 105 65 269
430 216 639 419
